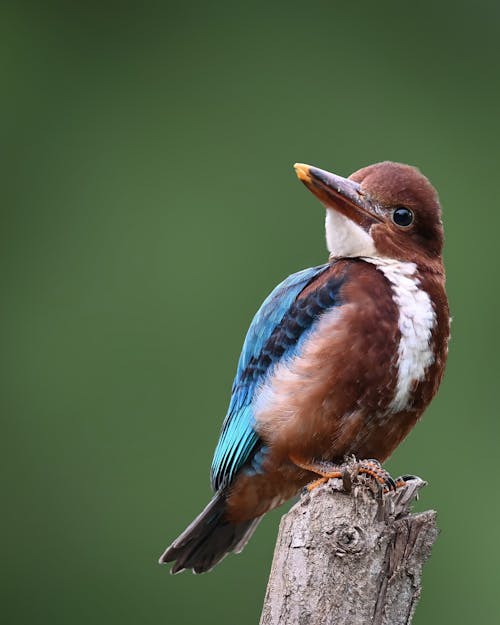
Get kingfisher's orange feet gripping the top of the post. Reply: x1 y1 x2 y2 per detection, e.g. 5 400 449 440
290 456 400 493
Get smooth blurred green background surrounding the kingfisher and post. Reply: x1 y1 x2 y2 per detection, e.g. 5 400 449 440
0 0 500 625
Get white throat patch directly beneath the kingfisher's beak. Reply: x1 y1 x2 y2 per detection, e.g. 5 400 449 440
325 208 378 258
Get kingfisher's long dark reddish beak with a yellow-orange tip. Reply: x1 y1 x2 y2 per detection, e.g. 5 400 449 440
294 163 382 231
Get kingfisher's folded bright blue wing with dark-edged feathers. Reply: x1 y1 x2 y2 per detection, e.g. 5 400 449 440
212 264 330 490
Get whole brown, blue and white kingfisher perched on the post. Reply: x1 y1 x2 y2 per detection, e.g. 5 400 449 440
160 161 450 573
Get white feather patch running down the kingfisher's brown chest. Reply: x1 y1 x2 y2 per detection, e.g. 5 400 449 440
364 257 436 412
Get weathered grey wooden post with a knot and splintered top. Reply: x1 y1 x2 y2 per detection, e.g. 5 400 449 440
260 478 438 625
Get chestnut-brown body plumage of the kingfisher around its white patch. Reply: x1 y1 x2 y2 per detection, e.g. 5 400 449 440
230 259 449 518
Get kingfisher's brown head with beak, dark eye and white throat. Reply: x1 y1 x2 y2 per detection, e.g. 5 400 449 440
295 161 443 265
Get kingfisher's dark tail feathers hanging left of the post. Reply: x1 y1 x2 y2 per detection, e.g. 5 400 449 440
160 491 260 573
